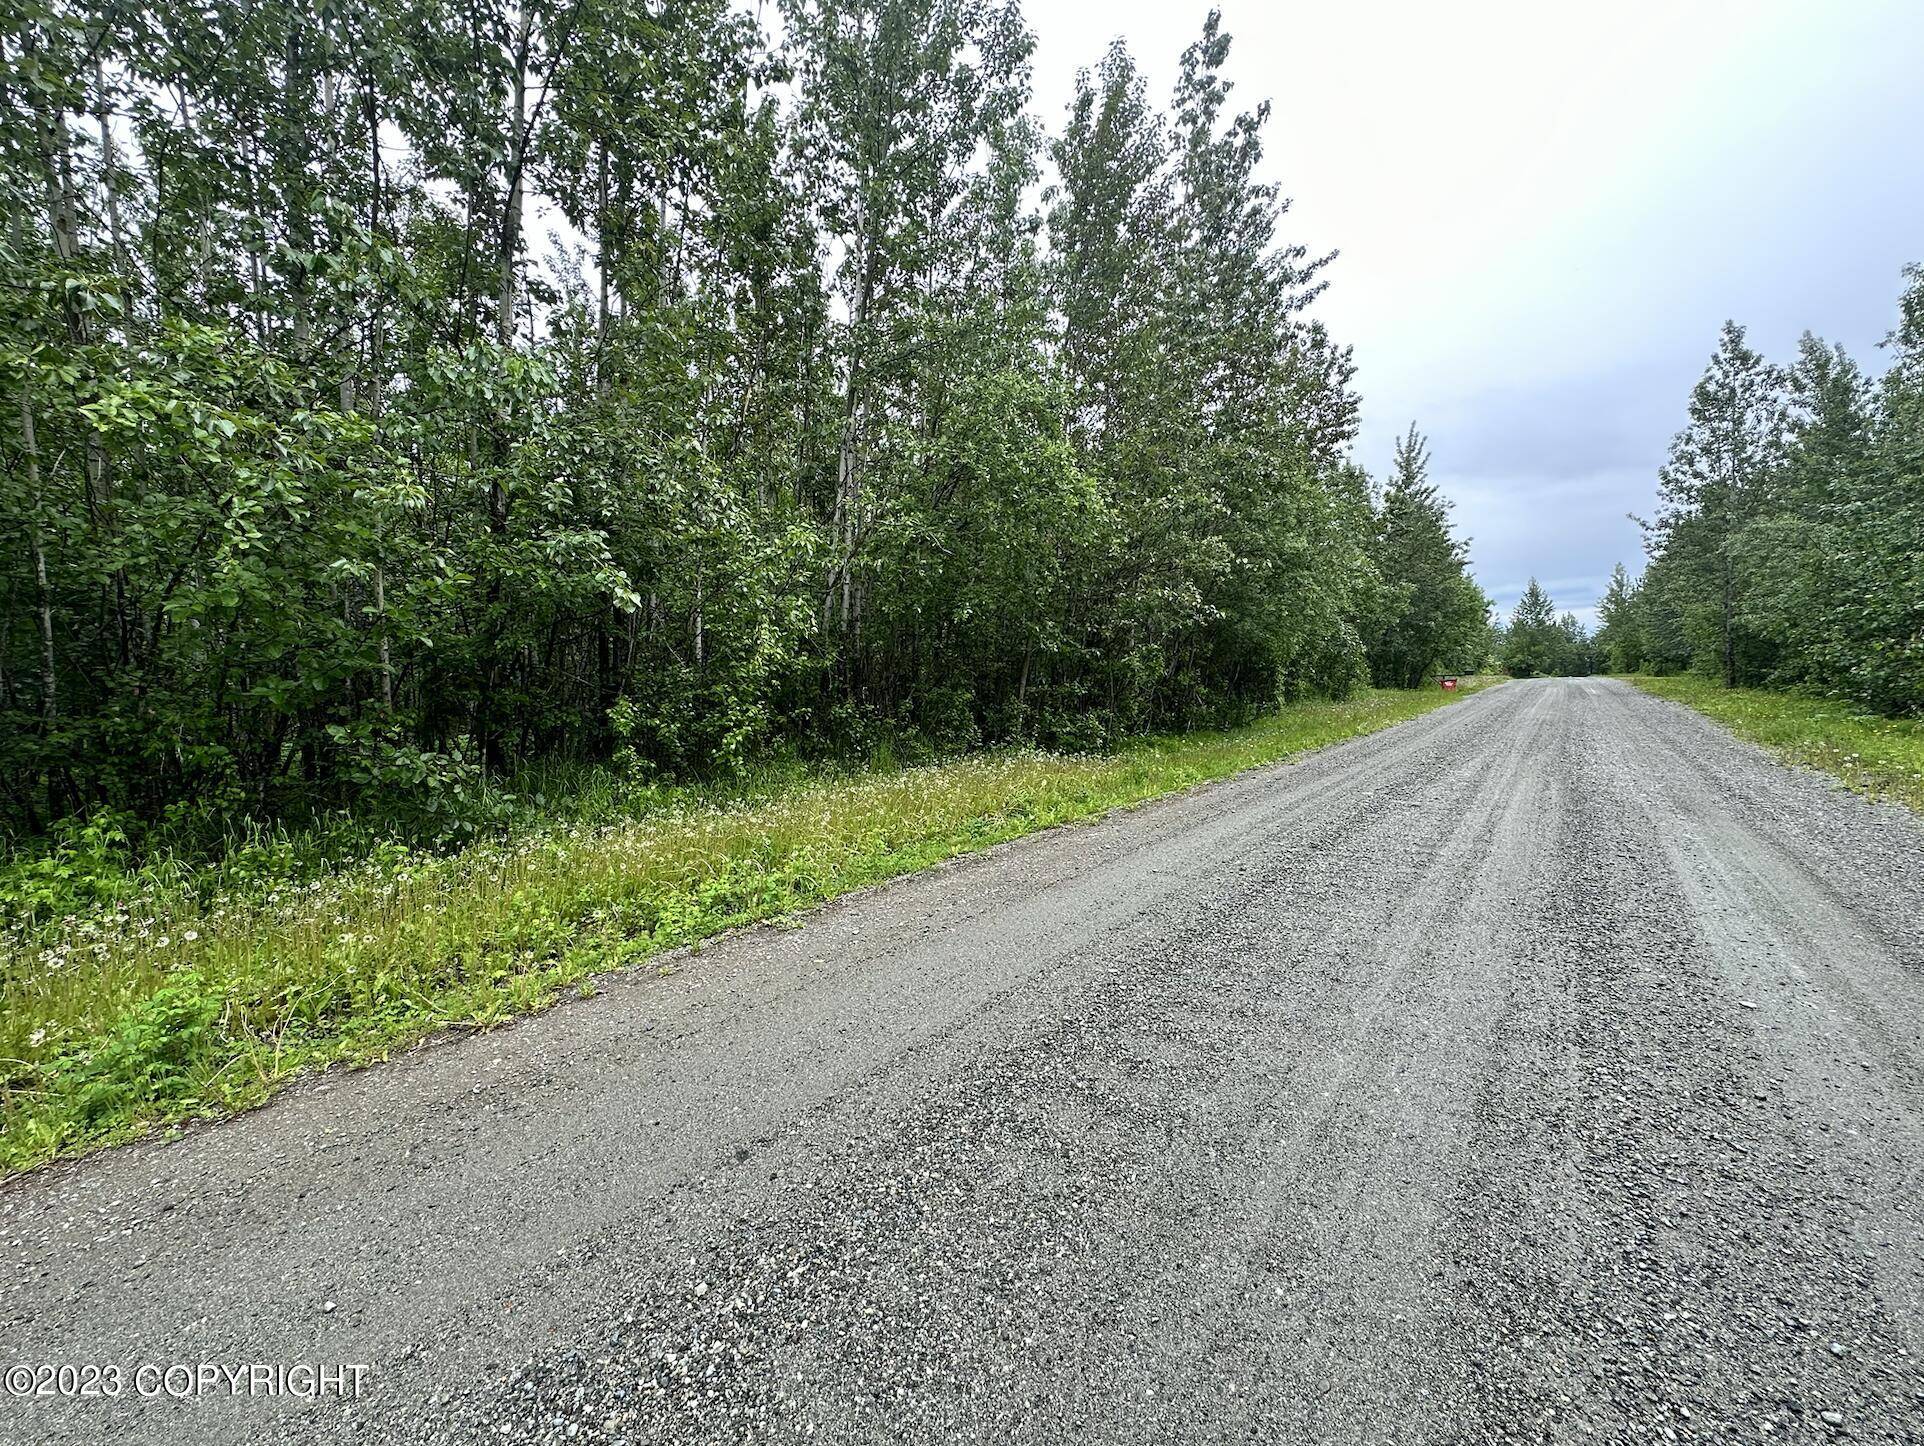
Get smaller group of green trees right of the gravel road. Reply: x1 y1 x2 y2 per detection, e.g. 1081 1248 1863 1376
1599 267 1924 715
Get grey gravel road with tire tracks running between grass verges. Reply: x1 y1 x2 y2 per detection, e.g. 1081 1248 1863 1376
0 679 1924 1442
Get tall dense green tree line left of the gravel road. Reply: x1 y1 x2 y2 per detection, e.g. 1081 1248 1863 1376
0 0 1487 833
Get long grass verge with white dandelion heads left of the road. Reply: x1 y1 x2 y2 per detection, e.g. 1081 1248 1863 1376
0 685 1474 1175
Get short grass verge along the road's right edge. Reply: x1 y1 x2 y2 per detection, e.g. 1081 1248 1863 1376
1630 673 1924 811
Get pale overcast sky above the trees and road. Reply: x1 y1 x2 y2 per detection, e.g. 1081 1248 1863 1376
1025 0 1924 619
